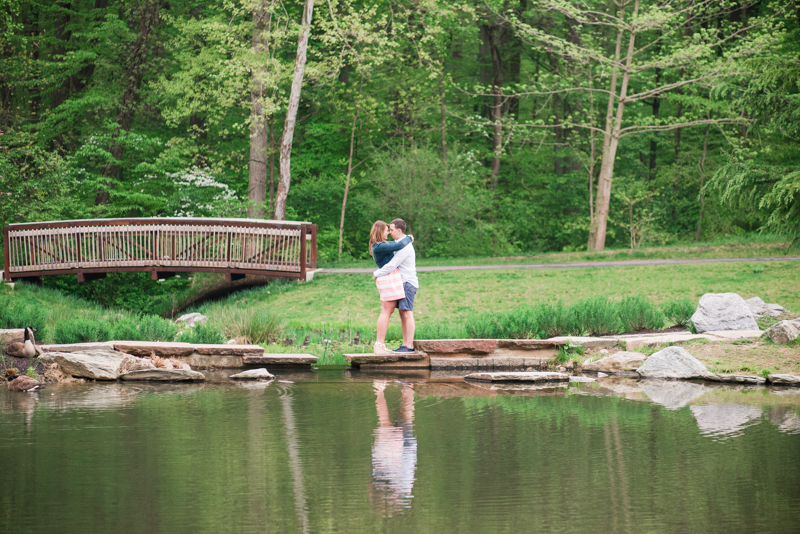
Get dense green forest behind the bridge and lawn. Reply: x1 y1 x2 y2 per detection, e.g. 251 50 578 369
0 0 800 268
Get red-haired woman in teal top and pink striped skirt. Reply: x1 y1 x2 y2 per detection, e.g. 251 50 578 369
369 221 414 354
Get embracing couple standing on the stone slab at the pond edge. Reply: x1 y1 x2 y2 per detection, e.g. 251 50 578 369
369 219 419 354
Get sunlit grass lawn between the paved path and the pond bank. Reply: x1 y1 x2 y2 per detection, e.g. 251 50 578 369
197 261 800 338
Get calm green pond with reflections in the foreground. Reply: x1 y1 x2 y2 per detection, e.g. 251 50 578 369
0 370 800 534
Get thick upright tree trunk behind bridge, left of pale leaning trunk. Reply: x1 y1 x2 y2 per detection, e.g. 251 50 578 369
247 1 272 219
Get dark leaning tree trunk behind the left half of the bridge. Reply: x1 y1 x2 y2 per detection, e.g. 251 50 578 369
94 0 161 206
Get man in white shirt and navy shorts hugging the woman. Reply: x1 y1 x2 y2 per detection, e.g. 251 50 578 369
372 219 419 352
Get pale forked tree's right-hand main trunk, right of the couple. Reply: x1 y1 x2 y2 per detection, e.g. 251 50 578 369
594 0 639 250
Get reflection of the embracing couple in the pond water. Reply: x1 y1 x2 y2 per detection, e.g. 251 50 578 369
370 380 417 517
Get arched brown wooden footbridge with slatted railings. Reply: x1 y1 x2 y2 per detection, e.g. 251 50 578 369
3 218 317 282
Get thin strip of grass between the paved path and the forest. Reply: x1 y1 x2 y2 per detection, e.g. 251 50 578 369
319 234 800 269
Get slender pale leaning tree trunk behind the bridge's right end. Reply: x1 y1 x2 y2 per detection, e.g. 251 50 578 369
275 0 314 221
